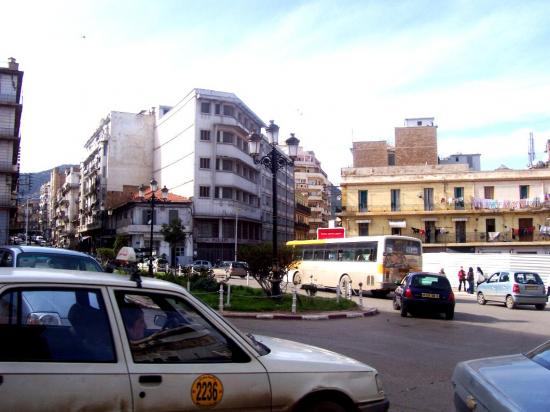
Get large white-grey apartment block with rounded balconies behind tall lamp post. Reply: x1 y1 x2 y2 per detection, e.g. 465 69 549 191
154 89 294 261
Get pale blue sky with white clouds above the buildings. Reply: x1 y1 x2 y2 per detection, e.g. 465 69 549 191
0 0 550 184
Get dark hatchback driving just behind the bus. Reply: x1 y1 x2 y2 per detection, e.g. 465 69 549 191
393 272 455 320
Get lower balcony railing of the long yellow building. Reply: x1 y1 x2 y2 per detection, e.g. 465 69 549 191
410 231 550 245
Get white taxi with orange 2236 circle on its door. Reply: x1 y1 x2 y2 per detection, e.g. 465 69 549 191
0 268 389 412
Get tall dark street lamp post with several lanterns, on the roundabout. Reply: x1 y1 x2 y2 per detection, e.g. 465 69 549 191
248 120 300 296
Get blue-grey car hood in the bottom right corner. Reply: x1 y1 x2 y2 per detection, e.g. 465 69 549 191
453 354 550 411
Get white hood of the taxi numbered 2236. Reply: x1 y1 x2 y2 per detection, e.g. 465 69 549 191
254 335 376 373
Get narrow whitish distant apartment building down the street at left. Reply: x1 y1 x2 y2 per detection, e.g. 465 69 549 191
53 166 80 249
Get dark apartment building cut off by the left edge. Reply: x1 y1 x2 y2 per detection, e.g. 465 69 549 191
0 57 23 244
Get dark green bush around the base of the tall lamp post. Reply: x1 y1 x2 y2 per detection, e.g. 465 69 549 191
238 243 294 298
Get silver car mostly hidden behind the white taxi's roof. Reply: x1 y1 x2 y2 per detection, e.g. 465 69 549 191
0 245 104 272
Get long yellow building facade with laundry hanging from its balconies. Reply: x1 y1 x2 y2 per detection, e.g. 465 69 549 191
340 164 550 253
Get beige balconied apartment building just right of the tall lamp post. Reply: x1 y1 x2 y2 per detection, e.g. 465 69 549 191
294 147 331 239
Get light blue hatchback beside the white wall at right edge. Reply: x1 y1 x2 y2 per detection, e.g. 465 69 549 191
477 270 548 310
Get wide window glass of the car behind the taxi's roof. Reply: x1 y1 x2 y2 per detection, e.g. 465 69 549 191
16 252 103 272
